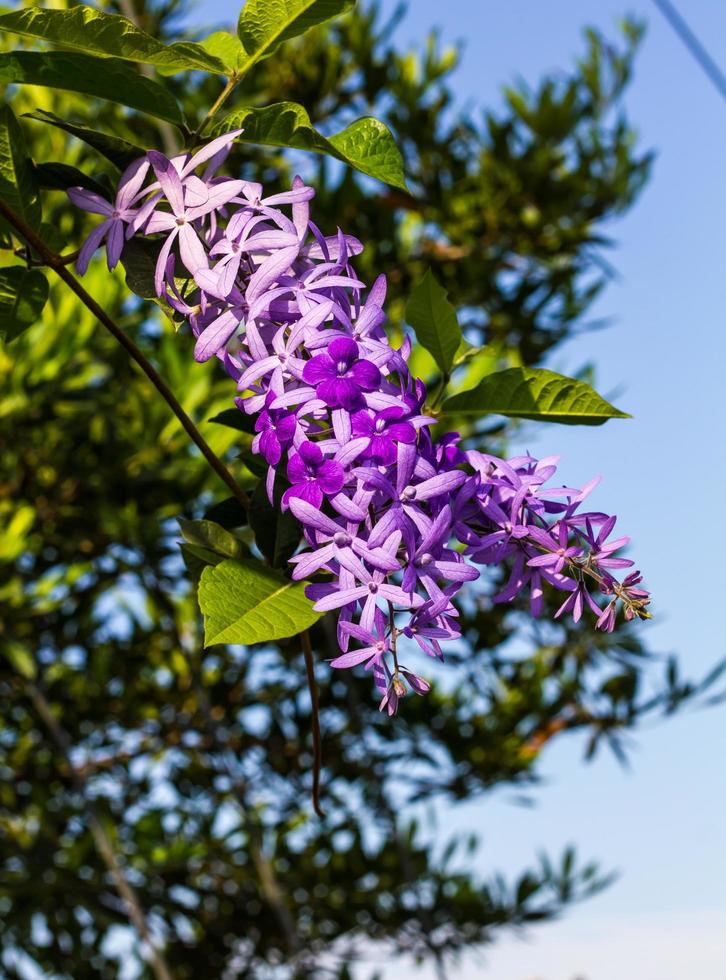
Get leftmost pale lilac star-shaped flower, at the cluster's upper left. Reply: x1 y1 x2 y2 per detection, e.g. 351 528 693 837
68 158 149 275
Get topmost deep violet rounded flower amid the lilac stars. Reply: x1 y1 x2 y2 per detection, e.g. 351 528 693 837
303 337 381 412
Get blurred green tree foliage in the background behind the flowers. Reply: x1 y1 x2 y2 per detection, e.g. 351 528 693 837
0 0 715 980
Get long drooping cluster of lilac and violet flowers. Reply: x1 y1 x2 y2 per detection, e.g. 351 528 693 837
70 133 649 714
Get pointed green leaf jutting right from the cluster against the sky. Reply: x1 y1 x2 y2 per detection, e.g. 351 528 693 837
443 368 630 425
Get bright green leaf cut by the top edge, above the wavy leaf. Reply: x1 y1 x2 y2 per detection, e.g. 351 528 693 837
237 0 355 72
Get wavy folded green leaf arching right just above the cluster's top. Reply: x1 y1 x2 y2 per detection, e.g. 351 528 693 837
213 102 406 190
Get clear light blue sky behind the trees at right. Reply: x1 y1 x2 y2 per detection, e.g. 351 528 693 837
199 0 726 980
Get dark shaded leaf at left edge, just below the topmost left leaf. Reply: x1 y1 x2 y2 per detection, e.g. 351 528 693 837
0 51 184 125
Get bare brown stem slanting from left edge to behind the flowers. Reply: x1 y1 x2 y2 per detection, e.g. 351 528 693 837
0 200 249 508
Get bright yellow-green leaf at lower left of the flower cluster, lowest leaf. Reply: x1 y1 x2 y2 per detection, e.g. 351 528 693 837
199 559 321 646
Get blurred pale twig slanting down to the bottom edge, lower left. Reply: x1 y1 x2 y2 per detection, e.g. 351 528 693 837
25 680 172 980
